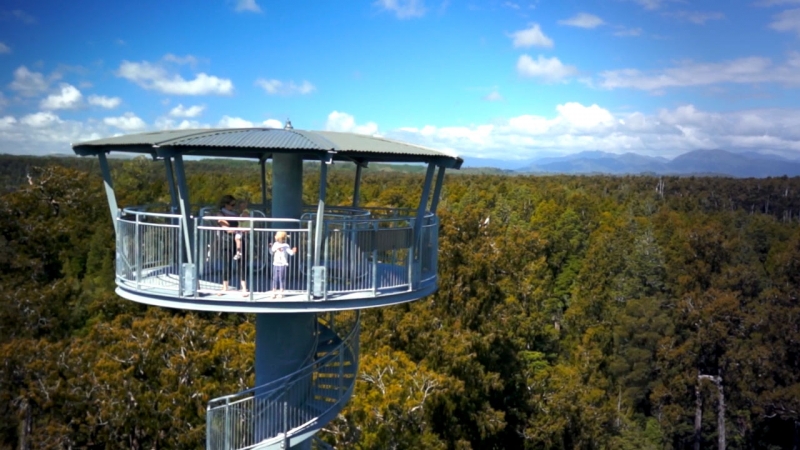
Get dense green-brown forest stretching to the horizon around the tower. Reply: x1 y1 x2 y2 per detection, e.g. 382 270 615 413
0 156 800 450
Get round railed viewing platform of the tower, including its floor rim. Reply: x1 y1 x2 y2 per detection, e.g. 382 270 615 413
116 205 439 313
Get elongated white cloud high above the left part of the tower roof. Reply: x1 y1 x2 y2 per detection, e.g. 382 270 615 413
117 61 233 95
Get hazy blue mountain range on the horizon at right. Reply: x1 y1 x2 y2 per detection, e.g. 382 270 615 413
465 150 800 178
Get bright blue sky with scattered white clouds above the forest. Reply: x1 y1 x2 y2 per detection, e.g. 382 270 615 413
0 0 800 163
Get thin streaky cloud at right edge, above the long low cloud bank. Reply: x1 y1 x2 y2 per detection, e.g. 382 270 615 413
599 52 800 92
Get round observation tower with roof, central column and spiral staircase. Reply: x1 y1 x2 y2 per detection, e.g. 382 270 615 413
72 127 463 450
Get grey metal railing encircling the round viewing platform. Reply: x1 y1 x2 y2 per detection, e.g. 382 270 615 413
112 206 438 301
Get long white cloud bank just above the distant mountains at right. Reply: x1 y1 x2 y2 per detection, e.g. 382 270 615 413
386 103 800 160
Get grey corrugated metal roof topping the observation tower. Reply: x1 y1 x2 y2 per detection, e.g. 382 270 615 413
72 128 463 168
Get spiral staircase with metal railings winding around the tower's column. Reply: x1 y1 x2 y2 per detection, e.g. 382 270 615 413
206 312 360 450
